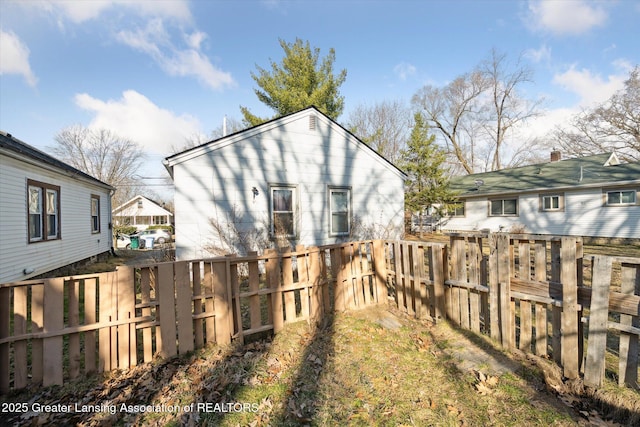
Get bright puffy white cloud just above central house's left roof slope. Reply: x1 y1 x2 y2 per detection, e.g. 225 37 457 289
75 90 201 156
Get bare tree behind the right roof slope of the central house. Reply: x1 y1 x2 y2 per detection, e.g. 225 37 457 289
347 101 413 163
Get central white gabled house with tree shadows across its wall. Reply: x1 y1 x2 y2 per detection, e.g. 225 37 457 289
164 107 406 259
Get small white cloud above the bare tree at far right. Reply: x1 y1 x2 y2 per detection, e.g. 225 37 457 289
553 66 628 107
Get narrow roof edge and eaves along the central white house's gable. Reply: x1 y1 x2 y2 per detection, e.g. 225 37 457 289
162 106 407 179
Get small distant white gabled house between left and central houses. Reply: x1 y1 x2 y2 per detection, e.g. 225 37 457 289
112 196 173 231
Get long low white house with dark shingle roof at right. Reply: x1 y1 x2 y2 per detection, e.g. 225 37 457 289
442 151 640 239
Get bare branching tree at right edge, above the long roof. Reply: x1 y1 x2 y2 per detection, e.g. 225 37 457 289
552 66 640 161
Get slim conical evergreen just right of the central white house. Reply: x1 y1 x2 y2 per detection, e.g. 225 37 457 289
401 113 455 232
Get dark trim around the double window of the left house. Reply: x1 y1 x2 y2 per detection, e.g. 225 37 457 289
26 179 62 244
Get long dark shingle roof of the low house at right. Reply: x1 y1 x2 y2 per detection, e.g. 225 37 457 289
451 153 640 198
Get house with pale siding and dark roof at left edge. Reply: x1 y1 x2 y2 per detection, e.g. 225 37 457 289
0 131 114 283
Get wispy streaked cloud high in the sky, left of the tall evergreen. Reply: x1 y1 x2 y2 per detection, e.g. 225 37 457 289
116 19 235 89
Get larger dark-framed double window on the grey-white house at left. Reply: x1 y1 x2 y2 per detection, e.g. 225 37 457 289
27 180 60 242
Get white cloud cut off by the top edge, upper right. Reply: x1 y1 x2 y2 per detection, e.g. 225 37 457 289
527 0 608 35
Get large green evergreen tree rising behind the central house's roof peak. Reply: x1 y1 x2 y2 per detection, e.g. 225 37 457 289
240 39 347 126
